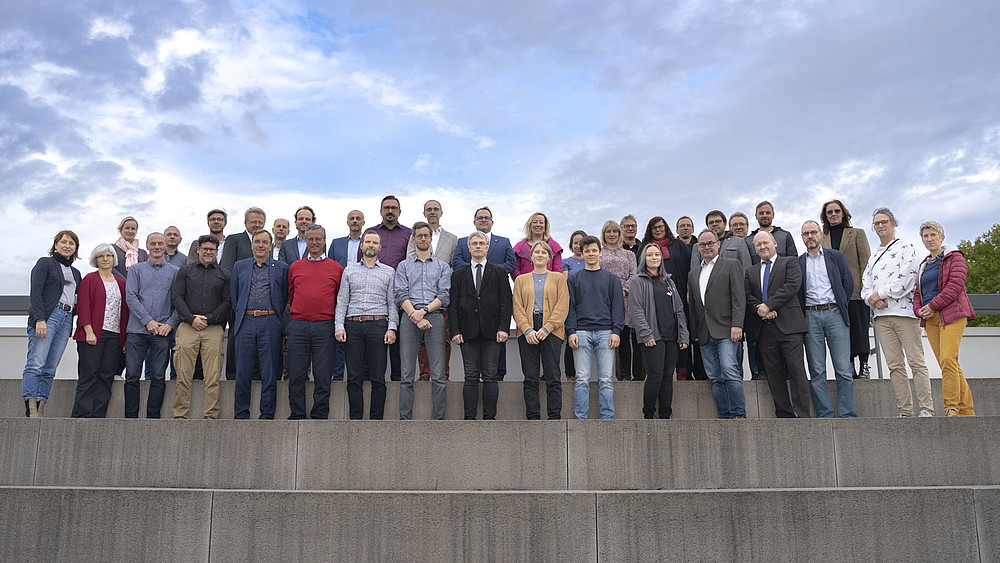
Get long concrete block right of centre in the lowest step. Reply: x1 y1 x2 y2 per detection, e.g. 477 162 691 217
597 489 976 563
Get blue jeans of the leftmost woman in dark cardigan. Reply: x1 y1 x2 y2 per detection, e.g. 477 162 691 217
21 308 73 401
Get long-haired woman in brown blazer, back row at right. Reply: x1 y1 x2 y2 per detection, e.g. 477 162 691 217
819 199 872 379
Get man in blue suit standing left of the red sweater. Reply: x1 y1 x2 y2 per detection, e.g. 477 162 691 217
230 229 288 420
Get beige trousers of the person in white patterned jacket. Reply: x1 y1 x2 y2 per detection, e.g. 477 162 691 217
875 316 934 416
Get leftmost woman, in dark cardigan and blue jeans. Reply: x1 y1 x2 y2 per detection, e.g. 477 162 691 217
21 231 80 418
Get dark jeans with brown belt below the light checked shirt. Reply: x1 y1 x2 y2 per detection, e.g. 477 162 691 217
344 319 389 420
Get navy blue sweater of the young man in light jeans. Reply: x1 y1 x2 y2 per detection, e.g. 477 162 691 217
566 270 625 336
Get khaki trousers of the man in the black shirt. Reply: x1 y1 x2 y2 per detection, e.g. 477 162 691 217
174 323 223 418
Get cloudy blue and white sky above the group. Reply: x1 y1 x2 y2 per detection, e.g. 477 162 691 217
0 0 1000 294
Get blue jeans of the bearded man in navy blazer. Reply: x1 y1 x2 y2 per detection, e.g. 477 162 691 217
803 308 858 418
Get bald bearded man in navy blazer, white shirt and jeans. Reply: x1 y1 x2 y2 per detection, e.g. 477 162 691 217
799 221 857 418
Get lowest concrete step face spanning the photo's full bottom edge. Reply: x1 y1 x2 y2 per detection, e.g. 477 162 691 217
0 487 1000 563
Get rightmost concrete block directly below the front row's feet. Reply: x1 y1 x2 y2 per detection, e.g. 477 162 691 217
833 417 1000 487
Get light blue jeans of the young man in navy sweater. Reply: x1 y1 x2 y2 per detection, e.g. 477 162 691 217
573 330 615 420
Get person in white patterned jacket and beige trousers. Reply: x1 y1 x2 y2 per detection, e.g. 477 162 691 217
861 207 934 417
